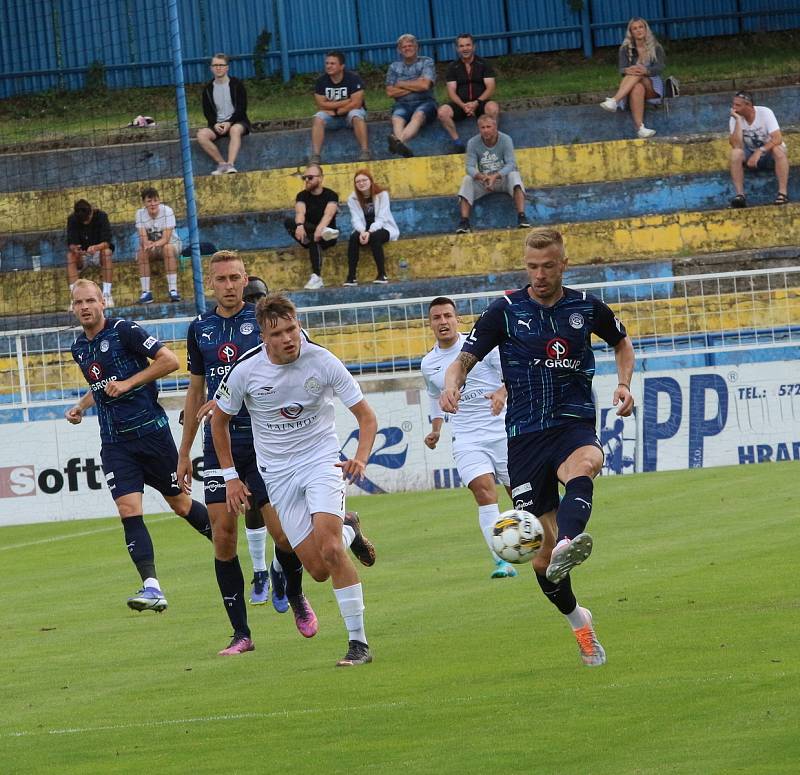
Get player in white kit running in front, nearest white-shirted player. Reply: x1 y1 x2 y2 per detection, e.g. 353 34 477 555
211 294 378 667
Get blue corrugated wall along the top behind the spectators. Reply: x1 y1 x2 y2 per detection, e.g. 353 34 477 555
0 0 800 98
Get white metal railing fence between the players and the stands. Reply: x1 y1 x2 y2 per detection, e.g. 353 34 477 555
0 267 800 420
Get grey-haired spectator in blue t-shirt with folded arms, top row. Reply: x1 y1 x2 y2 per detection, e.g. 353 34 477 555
386 33 438 156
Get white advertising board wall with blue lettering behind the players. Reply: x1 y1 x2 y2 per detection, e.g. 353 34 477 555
0 360 800 526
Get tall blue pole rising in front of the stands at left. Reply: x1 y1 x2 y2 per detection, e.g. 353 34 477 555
164 0 206 315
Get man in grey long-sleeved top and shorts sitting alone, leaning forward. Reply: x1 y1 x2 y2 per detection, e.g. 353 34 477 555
456 115 530 234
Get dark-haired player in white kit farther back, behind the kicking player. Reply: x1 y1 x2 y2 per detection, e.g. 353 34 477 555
421 296 517 579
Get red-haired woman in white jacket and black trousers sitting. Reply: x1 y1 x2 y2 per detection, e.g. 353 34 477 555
344 169 400 285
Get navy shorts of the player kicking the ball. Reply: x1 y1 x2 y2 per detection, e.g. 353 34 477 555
508 420 602 516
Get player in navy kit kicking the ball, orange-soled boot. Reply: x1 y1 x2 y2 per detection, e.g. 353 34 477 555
441 229 634 666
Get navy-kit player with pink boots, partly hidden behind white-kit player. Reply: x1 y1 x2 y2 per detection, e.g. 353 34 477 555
178 250 317 656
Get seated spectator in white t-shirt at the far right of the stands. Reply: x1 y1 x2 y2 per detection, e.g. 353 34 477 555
729 91 789 207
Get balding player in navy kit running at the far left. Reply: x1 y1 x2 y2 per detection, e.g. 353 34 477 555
66 280 211 611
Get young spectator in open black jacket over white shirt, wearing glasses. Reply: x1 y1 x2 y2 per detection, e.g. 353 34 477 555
197 54 250 175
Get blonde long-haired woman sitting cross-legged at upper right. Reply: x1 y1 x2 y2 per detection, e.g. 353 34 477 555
600 16 665 139
